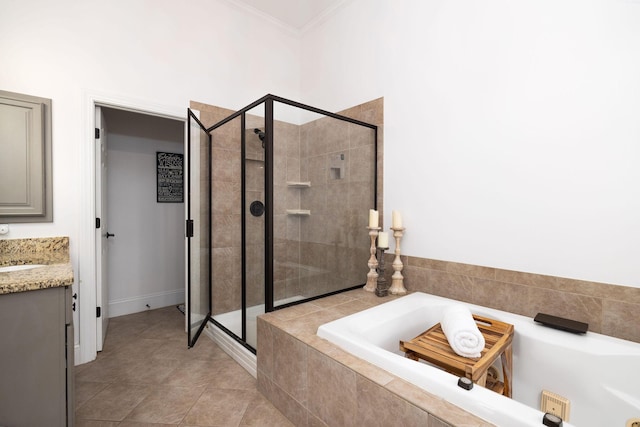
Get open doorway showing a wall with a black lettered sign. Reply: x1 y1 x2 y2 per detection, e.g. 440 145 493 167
96 107 185 351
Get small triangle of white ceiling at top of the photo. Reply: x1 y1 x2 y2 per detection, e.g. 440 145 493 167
231 0 349 31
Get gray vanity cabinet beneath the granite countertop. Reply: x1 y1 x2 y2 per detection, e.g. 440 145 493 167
0 286 75 427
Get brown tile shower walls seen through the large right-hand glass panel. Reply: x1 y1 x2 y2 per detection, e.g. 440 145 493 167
274 99 383 299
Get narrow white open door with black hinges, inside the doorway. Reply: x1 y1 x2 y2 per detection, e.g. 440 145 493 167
96 106 113 351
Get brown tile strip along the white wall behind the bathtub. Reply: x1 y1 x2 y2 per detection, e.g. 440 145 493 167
402 256 640 342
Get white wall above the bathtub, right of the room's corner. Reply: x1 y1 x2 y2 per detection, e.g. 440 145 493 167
301 0 640 287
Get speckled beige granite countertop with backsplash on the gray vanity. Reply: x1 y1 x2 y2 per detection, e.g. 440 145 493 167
0 237 74 295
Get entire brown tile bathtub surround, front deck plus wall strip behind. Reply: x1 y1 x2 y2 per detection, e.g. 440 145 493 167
258 260 640 427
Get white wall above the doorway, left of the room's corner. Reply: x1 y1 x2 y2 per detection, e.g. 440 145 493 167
0 0 300 363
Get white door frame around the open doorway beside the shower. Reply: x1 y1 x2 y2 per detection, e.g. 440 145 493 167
74 90 188 364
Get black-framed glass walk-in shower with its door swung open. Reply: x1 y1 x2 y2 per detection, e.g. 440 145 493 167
187 95 378 353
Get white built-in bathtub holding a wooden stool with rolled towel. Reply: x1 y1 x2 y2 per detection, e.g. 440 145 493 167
317 293 640 427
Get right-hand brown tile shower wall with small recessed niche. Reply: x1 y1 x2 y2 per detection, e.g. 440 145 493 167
300 117 375 296
